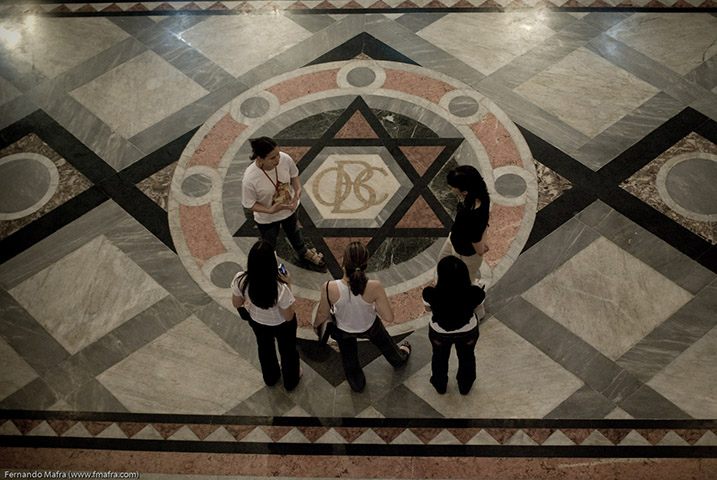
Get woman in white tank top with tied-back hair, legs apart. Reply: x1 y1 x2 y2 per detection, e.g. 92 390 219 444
314 242 411 392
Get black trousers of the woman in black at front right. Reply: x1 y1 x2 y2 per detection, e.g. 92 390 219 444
428 325 480 395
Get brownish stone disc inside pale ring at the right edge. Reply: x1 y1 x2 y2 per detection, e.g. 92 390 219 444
665 158 717 215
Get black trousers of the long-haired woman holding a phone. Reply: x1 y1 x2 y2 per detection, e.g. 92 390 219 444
249 315 300 390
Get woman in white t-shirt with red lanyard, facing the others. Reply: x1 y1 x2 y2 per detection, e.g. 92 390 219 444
242 137 325 268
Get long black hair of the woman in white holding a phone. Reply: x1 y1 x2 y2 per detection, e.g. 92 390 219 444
239 240 283 309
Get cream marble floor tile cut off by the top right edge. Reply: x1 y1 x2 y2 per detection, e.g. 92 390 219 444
607 12 717 75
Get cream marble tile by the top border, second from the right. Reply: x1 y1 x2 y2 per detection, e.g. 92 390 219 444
418 10 555 75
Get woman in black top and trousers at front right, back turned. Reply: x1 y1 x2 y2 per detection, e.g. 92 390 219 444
423 256 485 395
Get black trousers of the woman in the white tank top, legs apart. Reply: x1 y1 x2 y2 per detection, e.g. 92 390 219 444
331 317 408 392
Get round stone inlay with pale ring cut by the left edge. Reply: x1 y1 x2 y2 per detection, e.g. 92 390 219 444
0 153 57 215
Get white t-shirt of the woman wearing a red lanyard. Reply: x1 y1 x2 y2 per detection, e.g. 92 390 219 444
241 152 299 224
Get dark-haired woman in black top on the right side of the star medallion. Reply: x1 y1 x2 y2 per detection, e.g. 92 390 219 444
438 165 490 282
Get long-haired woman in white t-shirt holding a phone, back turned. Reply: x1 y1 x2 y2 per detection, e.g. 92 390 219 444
231 240 301 390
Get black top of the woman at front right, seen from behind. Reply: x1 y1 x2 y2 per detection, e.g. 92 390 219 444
423 285 485 332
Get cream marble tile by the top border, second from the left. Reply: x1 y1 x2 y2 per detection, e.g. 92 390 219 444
179 15 311 77
